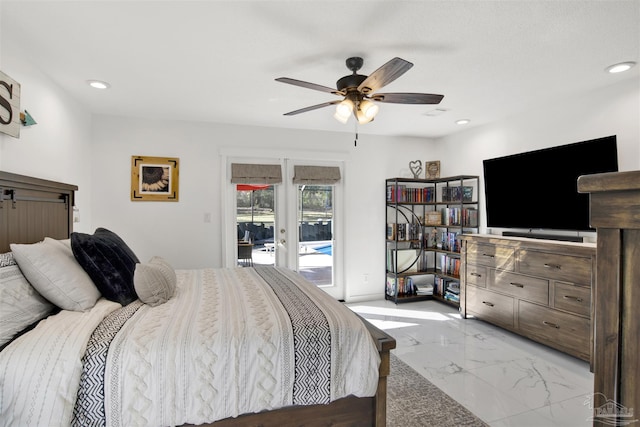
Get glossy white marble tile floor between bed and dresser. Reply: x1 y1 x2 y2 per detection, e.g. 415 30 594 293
347 300 593 427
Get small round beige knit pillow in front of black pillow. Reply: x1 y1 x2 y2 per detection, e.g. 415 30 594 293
133 256 177 307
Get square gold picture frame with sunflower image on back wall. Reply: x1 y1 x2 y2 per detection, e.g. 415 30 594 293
131 156 180 202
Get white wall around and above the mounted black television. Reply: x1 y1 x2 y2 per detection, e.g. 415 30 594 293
437 78 640 240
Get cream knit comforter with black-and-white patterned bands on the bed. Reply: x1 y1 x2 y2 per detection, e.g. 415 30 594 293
0 267 380 426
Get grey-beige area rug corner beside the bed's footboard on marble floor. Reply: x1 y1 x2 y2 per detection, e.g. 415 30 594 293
387 354 487 427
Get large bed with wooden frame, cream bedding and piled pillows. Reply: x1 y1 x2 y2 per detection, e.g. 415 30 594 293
0 172 395 426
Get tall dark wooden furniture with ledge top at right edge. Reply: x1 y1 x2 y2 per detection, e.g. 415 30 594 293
578 171 640 425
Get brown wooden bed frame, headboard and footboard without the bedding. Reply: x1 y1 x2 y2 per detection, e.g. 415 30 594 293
0 171 396 427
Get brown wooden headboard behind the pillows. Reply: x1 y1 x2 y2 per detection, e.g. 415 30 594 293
0 171 78 253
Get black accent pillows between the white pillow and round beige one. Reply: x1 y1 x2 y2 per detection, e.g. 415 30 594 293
71 228 140 305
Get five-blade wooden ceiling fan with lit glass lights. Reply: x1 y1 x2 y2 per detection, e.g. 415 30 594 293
276 57 444 124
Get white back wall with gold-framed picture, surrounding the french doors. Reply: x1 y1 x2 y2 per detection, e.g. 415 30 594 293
90 116 436 300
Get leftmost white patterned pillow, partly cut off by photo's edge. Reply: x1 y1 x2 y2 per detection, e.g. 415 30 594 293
0 252 55 348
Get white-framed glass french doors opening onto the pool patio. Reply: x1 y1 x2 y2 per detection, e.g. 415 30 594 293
225 158 344 299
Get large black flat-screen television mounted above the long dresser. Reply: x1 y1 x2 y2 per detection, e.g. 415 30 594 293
483 135 618 231
